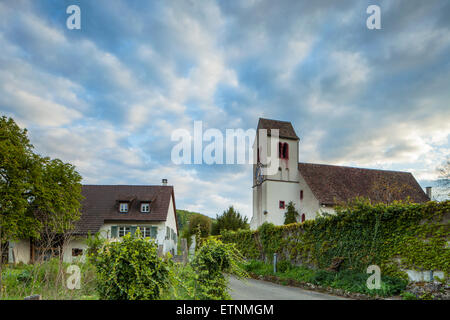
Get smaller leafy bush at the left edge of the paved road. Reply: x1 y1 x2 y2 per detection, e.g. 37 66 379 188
191 238 246 300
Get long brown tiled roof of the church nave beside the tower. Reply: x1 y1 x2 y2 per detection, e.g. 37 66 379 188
298 163 430 205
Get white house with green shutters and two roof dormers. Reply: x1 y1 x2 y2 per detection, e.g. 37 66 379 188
8 179 178 263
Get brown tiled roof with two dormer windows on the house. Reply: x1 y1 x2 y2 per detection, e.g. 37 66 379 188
75 185 176 235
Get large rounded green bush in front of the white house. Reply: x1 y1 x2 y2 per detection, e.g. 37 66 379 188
89 229 171 300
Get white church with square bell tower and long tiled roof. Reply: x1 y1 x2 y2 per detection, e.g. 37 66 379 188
250 118 431 229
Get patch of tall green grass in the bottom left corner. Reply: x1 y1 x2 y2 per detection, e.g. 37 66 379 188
2 259 98 300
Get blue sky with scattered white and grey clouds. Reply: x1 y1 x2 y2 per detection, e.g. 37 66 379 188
0 0 450 218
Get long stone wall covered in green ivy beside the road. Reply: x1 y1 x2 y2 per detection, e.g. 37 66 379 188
220 199 450 278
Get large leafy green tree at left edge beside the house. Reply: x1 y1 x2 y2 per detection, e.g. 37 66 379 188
0 116 82 294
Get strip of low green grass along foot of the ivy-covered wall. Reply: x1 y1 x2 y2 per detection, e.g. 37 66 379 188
243 260 407 297
